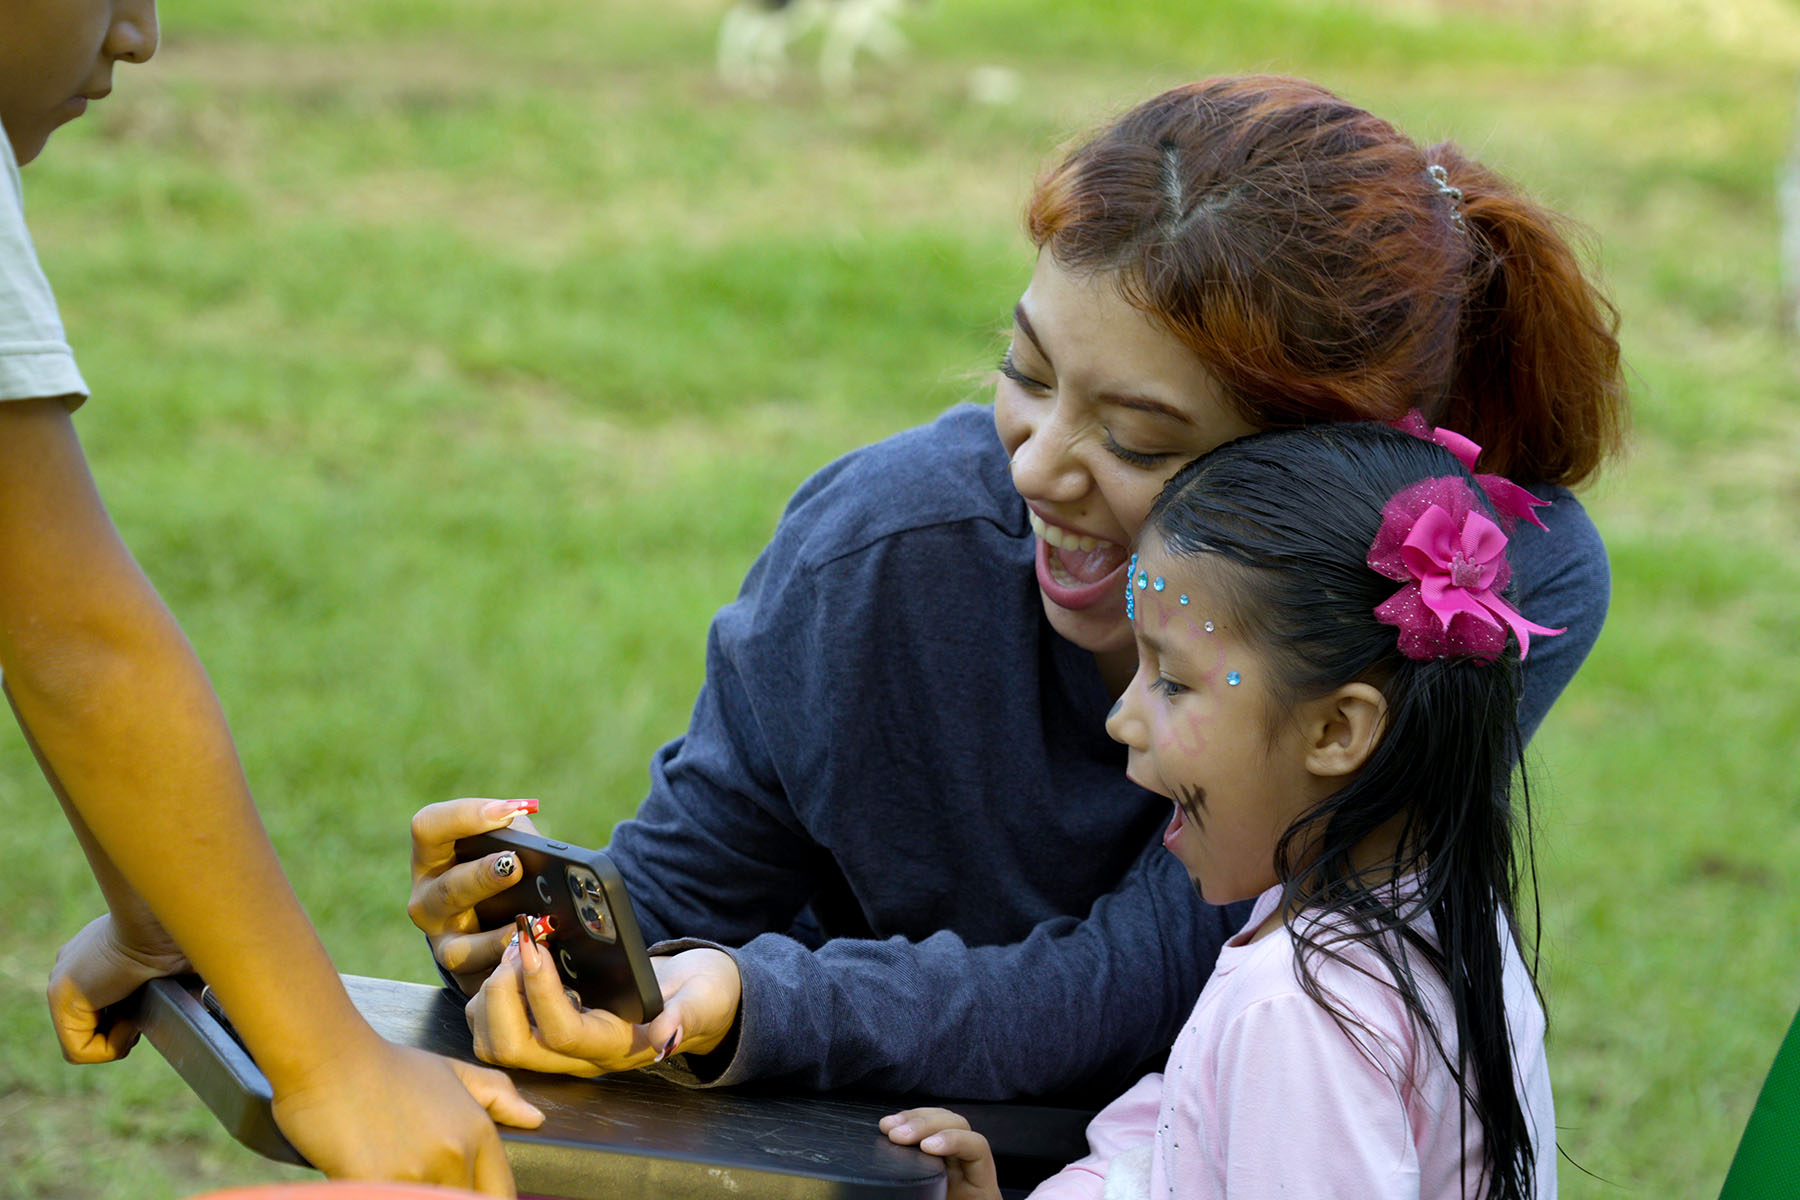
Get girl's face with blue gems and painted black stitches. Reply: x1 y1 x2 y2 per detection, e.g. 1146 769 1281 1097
1107 534 1319 905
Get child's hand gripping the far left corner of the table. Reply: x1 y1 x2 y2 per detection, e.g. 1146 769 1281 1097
45 912 189 1063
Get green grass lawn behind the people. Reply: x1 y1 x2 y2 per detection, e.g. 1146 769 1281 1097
0 0 1800 1200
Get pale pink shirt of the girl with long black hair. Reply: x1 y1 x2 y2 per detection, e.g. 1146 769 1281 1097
1031 889 1557 1200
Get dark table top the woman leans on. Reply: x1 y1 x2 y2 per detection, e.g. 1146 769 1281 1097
135 975 1091 1200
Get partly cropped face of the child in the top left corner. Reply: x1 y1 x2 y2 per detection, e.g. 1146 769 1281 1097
0 0 158 164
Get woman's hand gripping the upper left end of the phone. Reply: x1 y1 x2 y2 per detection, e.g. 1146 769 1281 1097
407 797 538 993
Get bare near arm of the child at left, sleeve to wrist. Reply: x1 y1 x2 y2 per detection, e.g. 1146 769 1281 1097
0 405 374 1088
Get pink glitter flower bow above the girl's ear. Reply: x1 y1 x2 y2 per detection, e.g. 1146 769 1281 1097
1368 475 1562 662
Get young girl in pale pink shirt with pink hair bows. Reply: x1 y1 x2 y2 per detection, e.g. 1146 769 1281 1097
882 425 1557 1200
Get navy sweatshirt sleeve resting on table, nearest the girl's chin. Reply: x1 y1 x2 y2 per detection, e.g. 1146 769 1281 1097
658 844 1247 1099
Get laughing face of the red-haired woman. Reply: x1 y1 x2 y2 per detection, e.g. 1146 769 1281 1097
994 254 1255 657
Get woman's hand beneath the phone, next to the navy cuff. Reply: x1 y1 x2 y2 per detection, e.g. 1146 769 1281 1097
466 939 743 1076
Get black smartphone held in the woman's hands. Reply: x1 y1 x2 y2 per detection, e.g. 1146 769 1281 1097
455 829 662 1025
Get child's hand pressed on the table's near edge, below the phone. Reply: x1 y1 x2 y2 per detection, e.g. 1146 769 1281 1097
274 1038 544 1196
